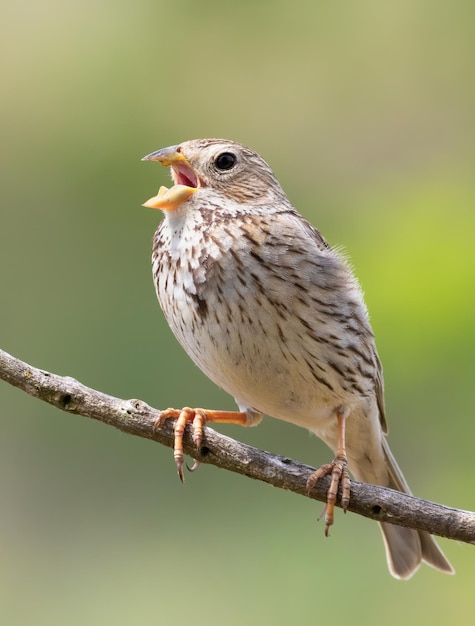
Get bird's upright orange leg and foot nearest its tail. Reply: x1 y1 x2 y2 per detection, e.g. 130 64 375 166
307 407 350 537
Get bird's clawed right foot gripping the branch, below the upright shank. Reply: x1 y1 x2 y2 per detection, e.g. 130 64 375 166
307 455 350 537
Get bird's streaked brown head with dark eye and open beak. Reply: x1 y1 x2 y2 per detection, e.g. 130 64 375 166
142 139 285 211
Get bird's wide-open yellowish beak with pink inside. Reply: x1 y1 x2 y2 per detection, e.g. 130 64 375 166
142 146 200 211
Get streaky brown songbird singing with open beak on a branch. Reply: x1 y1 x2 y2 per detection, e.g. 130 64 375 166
142 139 454 579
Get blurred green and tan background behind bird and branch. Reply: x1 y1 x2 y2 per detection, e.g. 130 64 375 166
0 0 475 626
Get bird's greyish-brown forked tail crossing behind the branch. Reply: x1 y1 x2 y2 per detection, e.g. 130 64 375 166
380 439 454 580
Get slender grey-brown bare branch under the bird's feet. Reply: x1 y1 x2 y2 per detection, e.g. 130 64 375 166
0 350 475 544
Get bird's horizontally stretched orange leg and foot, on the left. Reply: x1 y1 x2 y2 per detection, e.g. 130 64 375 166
154 407 252 482
